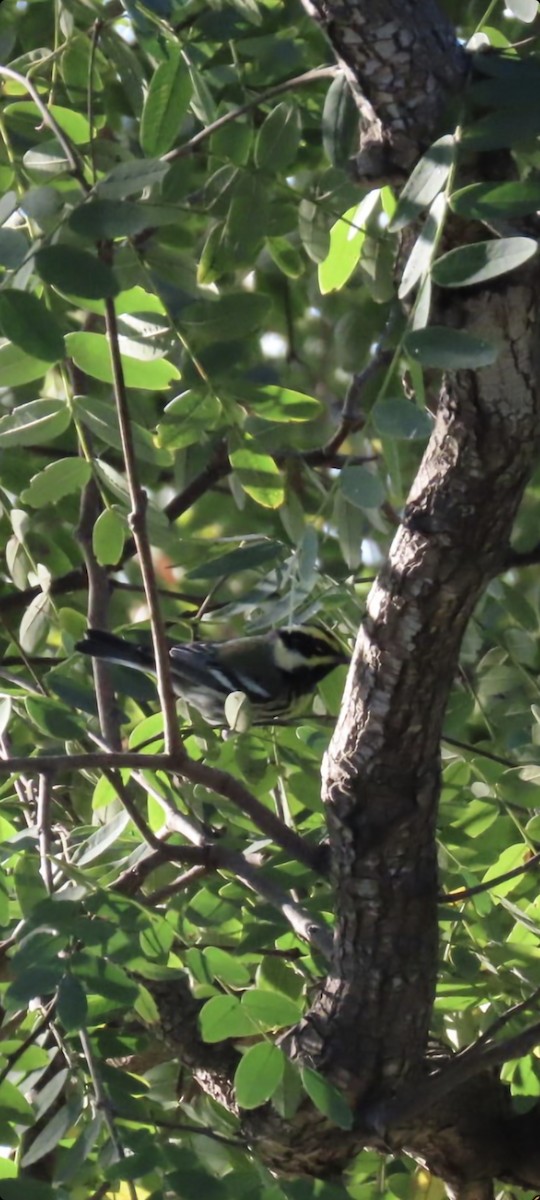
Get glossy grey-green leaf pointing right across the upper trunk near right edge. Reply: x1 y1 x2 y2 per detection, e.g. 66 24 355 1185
431 238 538 288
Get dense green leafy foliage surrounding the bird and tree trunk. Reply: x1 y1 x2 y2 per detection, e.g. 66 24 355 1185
0 0 540 1200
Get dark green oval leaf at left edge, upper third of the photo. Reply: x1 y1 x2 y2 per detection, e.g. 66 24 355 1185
0 288 65 362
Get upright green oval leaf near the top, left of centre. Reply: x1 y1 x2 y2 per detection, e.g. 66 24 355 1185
140 42 193 157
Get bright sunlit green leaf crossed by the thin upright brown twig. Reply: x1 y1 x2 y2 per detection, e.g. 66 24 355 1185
66 334 180 391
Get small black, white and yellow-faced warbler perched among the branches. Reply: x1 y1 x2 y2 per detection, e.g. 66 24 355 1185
76 625 348 725
